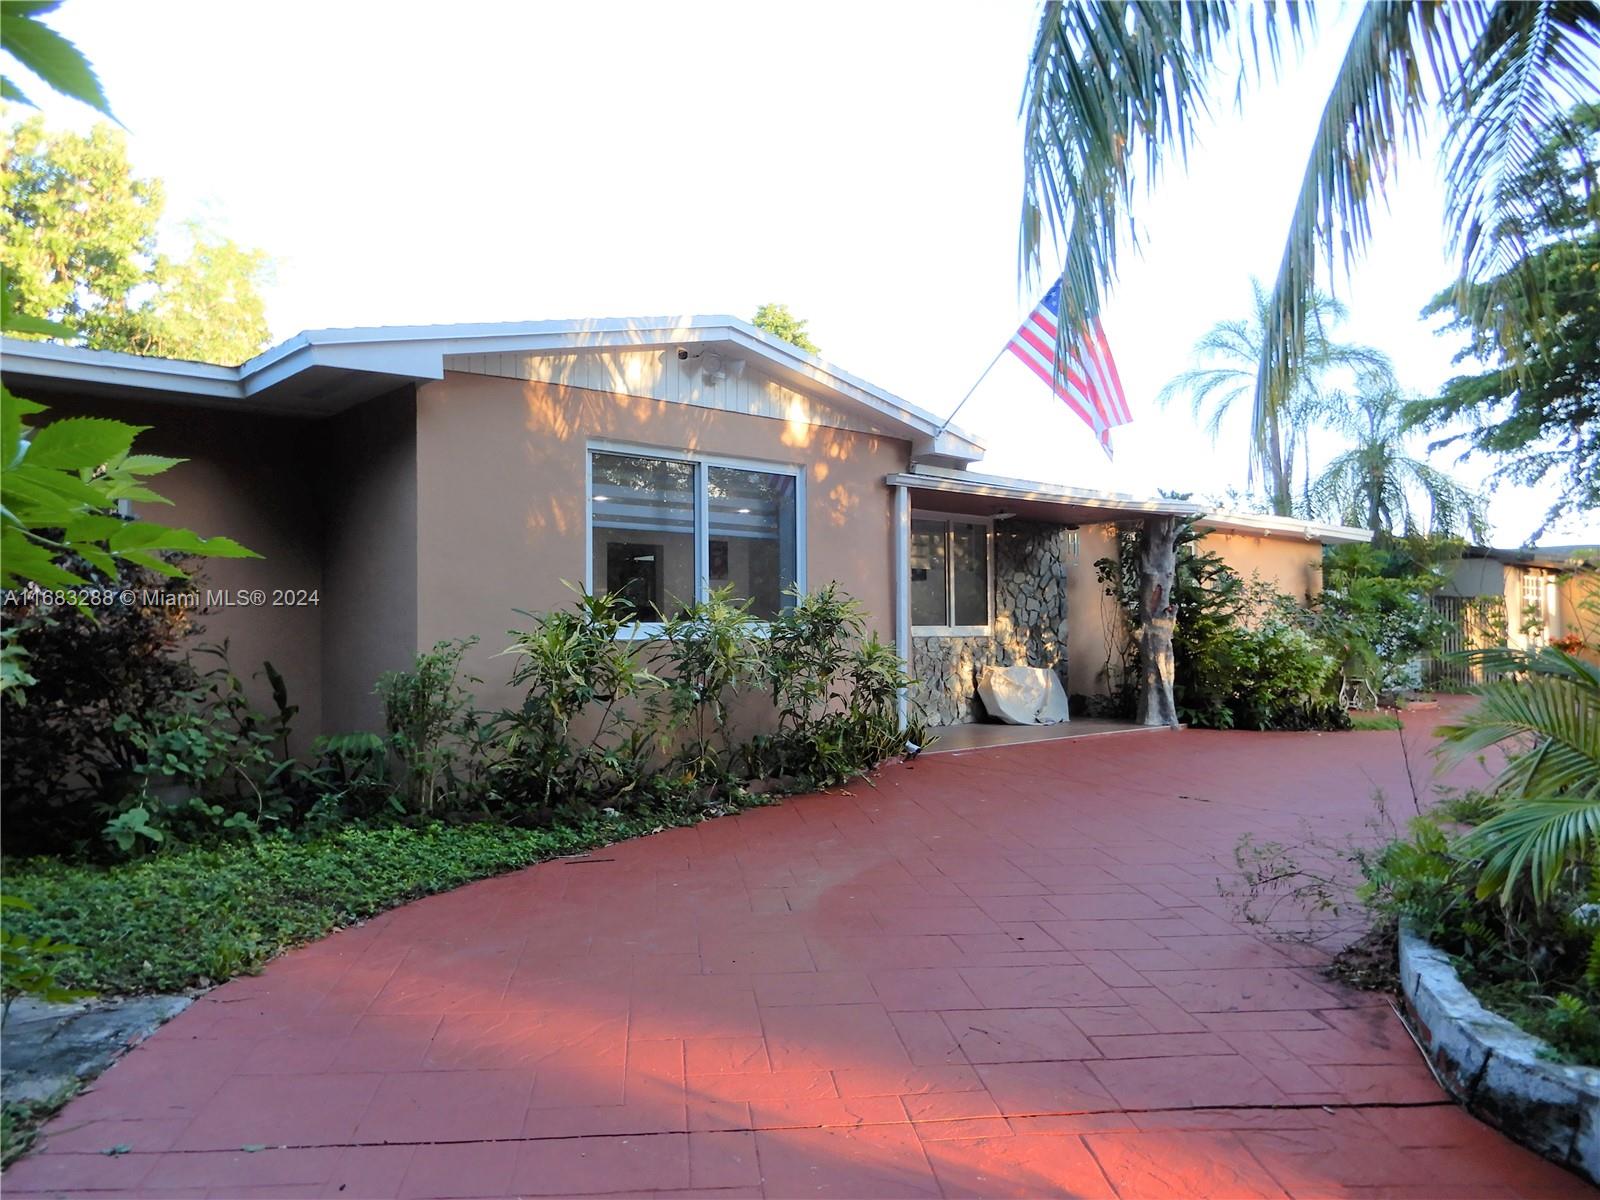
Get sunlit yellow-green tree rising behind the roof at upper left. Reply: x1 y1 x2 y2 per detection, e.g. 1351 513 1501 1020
0 117 270 365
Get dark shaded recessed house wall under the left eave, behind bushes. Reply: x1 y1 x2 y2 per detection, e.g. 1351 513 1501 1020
24 397 323 744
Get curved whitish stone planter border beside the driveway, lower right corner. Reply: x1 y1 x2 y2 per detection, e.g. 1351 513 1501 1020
1400 923 1600 1182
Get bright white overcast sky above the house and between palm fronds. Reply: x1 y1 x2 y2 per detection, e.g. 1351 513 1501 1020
21 0 1600 546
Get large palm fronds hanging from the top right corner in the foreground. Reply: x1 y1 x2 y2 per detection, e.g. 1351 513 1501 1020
1021 0 1600 492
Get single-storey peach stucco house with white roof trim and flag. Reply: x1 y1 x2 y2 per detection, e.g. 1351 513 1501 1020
0 317 1370 733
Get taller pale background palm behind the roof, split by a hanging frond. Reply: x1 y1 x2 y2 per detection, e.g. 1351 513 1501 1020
1155 278 1389 517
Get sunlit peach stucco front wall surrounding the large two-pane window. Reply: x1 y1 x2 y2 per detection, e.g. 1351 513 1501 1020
416 373 909 720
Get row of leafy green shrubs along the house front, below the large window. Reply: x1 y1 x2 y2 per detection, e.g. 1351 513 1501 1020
8 587 906 859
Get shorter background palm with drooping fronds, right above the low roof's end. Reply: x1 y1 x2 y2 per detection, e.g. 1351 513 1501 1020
1306 373 1488 541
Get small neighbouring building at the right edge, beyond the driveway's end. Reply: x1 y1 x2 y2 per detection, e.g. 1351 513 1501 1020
1432 546 1600 685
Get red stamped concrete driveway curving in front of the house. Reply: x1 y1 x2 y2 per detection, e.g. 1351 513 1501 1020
5 718 1590 1198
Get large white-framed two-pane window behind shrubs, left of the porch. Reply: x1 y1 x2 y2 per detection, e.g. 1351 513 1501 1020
589 450 800 624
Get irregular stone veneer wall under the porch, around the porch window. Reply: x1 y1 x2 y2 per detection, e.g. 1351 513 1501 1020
910 520 1067 725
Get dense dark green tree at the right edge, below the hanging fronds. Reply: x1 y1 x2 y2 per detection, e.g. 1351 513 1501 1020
1406 104 1600 541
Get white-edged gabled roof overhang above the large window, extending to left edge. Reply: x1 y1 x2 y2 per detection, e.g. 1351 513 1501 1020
0 317 984 464
